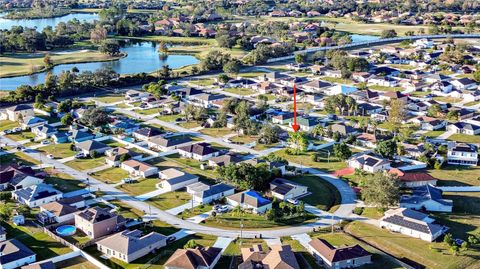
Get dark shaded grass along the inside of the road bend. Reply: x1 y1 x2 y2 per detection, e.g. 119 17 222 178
287 175 341 211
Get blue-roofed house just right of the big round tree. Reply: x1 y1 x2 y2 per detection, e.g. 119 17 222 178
400 184 453 212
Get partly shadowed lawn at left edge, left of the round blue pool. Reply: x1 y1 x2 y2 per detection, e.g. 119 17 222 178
2 222 72 260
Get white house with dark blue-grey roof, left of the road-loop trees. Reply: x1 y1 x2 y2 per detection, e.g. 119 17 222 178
187 182 235 204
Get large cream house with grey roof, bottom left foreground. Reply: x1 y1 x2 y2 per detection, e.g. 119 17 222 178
96 230 167 263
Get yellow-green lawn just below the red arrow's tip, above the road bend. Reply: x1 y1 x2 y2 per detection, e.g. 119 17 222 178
275 149 347 172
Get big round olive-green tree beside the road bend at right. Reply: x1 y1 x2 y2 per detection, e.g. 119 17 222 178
362 172 400 208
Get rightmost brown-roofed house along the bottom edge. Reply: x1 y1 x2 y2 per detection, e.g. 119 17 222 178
308 238 372 269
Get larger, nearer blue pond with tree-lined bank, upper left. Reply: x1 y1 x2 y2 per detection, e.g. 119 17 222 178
0 42 198 90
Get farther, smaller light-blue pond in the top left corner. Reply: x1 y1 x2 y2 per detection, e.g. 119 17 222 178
0 12 98 32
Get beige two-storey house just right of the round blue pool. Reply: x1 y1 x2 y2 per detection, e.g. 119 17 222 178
75 206 125 239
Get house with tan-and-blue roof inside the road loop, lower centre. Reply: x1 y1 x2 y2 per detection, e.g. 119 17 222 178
227 190 272 214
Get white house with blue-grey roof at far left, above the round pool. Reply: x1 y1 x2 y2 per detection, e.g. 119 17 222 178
12 183 63 207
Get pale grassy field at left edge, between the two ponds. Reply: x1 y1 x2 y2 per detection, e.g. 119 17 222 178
0 51 118 77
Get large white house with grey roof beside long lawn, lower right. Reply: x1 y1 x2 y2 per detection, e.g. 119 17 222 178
380 208 448 242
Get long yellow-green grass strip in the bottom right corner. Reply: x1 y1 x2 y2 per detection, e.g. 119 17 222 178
346 222 480 269
